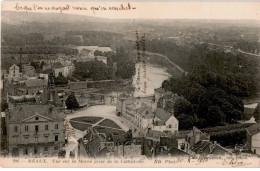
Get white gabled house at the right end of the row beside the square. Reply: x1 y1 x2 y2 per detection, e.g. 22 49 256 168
152 108 179 132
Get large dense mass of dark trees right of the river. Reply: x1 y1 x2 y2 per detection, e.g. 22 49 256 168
162 45 257 129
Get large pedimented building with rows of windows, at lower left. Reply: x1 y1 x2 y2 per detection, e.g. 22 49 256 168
6 104 65 157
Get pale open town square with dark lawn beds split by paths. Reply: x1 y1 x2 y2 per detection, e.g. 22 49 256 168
65 105 135 157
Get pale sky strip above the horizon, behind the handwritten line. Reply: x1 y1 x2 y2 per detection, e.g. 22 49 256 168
1 1 260 20
